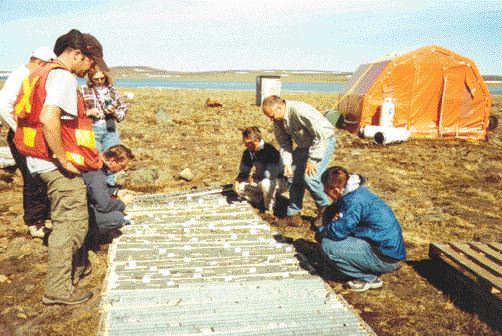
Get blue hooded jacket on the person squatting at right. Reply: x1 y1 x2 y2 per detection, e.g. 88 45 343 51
319 175 406 260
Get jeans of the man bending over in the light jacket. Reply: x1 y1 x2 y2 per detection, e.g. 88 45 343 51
287 137 336 216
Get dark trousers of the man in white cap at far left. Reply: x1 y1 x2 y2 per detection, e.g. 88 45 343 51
7 129 50 225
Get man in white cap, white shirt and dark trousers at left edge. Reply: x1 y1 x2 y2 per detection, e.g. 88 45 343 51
0 47 56 239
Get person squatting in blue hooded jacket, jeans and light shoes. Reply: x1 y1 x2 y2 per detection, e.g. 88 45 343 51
317 166 406 292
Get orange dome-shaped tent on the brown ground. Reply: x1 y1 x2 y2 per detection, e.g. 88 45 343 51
338 45 492 139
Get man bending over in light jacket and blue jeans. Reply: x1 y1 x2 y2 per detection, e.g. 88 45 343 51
262 95 336 227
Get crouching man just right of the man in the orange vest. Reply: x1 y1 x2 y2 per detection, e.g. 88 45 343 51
82 145 134 238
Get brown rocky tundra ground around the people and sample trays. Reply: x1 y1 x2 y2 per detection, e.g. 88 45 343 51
0 89 502 336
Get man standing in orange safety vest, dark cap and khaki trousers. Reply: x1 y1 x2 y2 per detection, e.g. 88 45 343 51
14 29 107 305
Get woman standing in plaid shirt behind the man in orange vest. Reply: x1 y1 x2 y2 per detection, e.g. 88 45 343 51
82 67 128 186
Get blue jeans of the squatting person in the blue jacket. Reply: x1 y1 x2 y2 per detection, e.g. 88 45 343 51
321 237 399 282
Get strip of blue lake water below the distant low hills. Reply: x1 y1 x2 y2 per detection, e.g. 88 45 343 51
0 76 502 95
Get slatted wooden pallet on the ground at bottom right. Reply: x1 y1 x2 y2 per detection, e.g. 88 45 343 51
429 242 502 299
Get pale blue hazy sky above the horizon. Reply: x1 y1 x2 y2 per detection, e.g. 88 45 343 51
0 0 502 75
